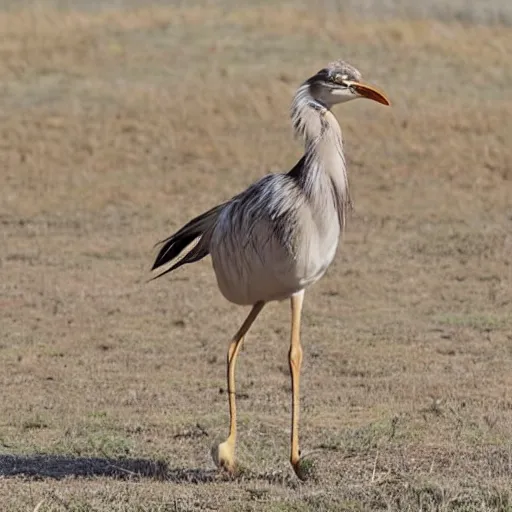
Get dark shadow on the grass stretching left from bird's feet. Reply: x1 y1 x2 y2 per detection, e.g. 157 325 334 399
0 454 295 487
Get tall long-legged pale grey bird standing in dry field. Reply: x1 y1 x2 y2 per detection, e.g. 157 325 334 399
151 60 390 479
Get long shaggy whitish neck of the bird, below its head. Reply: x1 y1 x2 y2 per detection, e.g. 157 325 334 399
291 83 351 228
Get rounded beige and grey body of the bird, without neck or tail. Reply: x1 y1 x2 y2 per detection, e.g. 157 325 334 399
210 168 339 305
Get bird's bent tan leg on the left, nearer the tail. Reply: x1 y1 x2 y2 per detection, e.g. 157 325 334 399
212 302 265 473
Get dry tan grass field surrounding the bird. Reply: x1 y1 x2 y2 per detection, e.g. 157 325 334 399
0 0 512 512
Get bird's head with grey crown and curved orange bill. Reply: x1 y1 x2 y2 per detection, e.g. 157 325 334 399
306 60 390 108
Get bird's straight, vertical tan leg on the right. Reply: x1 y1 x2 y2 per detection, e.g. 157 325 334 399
288 291 304 479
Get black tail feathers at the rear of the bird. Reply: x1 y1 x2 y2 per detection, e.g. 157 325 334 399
151 203 227 279
